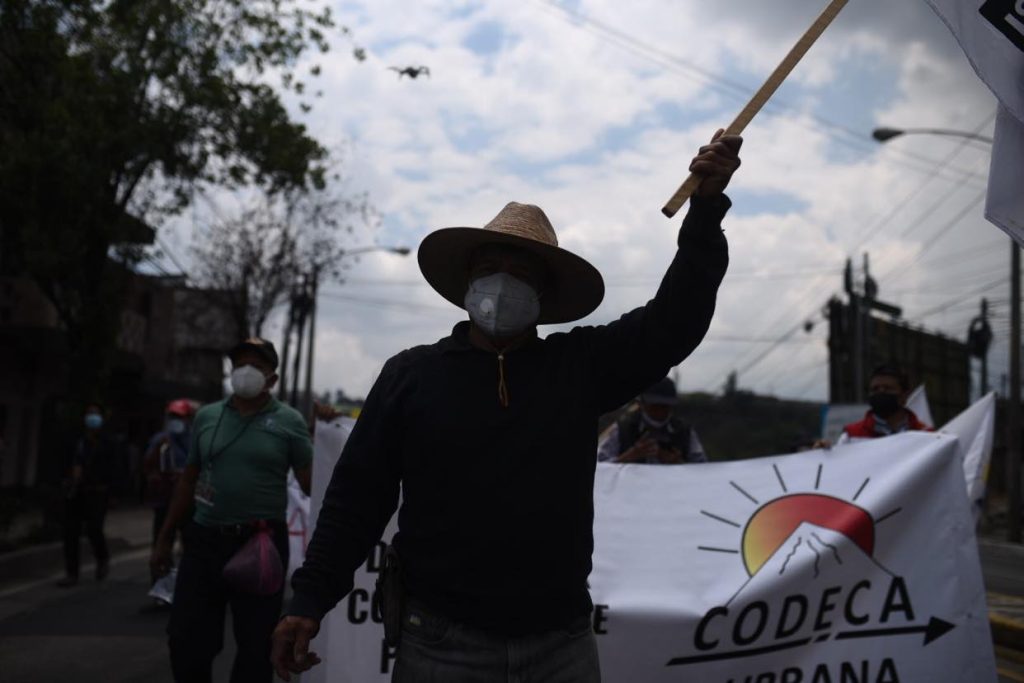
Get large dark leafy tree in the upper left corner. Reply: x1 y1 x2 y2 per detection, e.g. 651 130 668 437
0 0 350 400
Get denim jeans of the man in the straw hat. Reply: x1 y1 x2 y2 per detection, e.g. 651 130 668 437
391 602 601 683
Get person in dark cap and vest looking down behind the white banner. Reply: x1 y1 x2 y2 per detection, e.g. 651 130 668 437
597 377 708 465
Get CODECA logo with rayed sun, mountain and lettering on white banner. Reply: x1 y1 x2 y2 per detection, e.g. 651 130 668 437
668 458 953 682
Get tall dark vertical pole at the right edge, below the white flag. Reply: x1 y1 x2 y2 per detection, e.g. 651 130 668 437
1007 239 1021 543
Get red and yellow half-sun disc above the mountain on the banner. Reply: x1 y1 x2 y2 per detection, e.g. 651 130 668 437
742 494 874 577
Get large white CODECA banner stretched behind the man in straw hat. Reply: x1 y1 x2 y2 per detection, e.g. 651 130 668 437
303 423 995 683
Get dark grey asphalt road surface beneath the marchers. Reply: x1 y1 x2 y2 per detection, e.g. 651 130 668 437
0 551 1024 683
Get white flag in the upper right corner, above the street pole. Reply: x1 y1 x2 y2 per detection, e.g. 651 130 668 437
927 0 1024 246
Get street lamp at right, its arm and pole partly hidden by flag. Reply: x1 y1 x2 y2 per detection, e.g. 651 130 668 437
871 128 1021 543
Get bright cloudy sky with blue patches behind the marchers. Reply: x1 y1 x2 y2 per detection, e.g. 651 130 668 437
155 0 1009 400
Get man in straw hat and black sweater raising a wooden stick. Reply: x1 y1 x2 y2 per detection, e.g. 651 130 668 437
272 131 741 683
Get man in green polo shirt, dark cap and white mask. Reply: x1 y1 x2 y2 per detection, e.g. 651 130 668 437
151 337 312 683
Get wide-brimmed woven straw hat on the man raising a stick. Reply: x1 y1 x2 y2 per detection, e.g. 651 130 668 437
418 202 604 325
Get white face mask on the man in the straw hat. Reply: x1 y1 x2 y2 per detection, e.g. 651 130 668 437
463 272 541 338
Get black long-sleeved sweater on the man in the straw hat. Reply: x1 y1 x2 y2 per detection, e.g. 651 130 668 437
288 196 730 635
